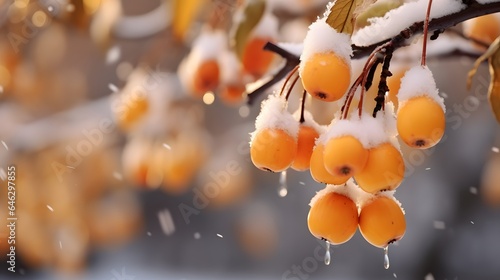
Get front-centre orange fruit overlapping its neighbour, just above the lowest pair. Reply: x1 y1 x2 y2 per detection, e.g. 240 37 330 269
323 135 368 181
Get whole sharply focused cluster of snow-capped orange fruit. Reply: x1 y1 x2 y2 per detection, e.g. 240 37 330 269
250 19 445 260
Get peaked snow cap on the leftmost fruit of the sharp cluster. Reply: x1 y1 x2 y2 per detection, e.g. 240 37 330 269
250 94 299 141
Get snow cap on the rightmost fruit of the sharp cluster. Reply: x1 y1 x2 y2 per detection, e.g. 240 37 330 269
398 65 446 112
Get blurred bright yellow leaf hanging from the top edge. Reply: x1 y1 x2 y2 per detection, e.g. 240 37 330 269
172 0 206 40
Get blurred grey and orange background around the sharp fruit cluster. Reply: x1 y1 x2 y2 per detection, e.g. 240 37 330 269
0 0 500 280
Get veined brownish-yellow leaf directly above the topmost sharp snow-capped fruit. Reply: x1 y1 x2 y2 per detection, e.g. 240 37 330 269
326 0 363 35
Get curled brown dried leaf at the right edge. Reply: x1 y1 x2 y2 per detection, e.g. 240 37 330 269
467 37 500 123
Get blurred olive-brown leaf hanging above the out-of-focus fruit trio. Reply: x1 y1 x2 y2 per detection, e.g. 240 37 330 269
231 0 266 59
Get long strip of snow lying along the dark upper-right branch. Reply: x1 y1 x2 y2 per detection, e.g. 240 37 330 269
352 0 466 46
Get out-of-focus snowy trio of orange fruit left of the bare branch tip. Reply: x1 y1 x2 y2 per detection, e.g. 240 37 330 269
178 13 278 105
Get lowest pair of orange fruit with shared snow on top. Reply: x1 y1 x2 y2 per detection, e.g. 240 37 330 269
307 180 406 248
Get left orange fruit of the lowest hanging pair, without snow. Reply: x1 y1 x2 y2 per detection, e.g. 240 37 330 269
307 192 358 244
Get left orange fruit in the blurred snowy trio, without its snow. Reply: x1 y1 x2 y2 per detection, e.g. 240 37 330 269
193 59 219 97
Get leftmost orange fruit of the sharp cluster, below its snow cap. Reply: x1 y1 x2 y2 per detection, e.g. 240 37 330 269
250 128 297 172
